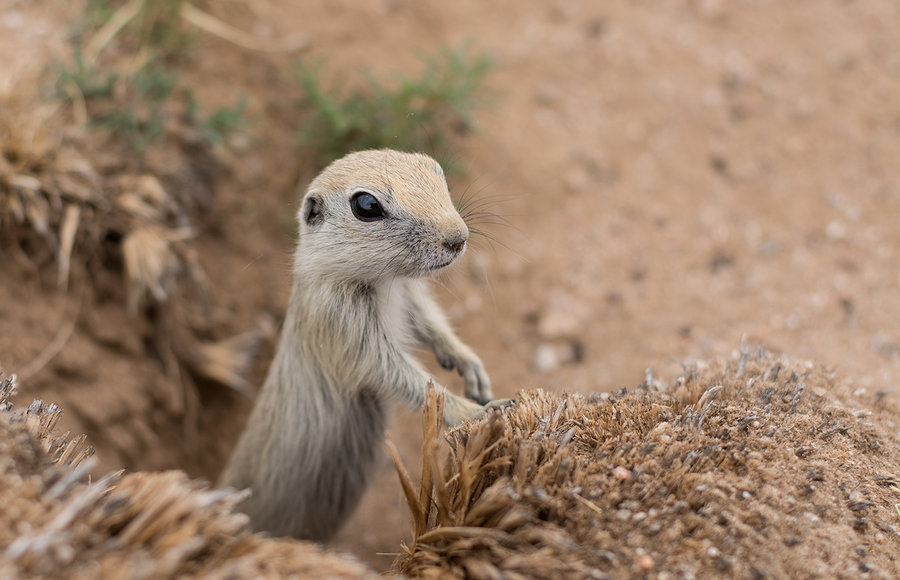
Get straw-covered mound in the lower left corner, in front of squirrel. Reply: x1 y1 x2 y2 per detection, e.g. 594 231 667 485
0 380 375 578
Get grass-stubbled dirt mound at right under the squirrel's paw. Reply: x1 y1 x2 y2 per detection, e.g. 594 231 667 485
397 348 900 578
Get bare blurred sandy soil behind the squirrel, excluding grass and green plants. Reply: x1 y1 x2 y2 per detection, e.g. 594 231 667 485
0 0 900 569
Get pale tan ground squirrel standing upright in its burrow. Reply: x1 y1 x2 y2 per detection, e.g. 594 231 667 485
220 150 492 541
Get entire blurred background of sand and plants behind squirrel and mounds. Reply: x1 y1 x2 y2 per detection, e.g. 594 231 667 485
0 0 900 569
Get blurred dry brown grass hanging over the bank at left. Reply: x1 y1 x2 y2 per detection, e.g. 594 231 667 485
0 74 265 406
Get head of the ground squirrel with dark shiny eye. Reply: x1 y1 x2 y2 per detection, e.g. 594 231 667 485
298 150 469 281
